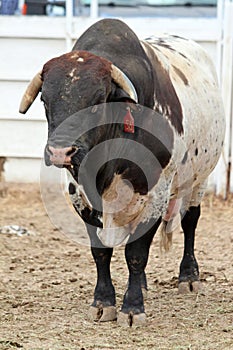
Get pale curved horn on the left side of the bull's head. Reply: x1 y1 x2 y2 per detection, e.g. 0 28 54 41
19 72 42 114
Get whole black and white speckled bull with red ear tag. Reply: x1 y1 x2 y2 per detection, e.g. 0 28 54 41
20 19 225 326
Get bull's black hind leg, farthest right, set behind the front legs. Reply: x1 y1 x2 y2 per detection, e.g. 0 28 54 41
179 205 201 293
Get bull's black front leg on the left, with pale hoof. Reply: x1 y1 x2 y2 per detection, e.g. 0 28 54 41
88 227 117 322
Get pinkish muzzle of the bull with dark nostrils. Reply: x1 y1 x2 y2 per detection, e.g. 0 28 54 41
46 146 78 167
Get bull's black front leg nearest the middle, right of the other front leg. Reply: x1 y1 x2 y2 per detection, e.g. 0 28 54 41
118 220 160 326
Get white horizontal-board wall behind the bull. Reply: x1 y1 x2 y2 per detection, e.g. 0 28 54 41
0 16 220 182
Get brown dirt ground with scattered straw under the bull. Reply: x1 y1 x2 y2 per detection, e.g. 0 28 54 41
0 184 233 350
